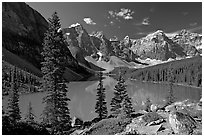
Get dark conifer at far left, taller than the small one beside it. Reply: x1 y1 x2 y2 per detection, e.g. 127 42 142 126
7 67 21 124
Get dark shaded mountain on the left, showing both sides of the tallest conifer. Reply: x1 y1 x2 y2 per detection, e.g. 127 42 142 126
2 2 101 81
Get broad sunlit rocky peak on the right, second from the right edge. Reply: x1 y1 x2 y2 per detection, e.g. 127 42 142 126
131 30 186 60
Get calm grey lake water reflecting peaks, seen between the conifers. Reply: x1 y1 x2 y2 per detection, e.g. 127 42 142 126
3 77 202 121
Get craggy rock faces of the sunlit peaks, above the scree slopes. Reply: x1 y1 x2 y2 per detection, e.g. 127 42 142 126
63 23 202 61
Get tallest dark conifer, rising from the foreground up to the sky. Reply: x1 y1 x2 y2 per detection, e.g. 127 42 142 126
41 12 71 134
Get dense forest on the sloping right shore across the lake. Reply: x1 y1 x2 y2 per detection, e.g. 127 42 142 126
111 56 202 87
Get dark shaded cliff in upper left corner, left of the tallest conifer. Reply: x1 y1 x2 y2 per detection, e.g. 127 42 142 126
2 2 48 68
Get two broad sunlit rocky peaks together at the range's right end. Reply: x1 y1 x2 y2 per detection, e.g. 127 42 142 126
131 30 202 61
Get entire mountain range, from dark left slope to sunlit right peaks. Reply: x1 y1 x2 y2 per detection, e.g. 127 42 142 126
2 2 202 80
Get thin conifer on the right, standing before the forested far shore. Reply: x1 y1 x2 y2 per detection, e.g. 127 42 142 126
166 64 176 105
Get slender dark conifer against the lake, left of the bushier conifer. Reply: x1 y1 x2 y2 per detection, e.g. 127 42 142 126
95 72 108 119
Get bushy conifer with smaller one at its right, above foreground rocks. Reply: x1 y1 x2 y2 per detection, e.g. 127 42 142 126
110 73 133 117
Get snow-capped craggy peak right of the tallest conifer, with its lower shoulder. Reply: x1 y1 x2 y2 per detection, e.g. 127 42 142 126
62 23 112 61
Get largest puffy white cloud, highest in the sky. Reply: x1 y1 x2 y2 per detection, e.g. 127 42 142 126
108 8 135 20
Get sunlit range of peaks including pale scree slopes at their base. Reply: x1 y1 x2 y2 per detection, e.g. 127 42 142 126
62 23 202 71
